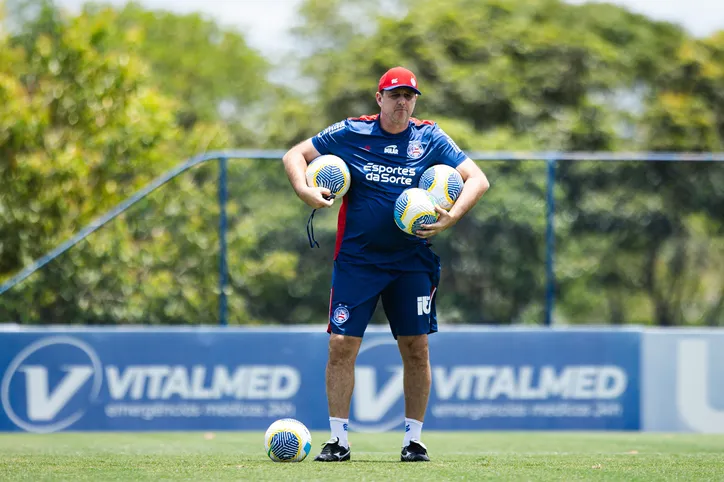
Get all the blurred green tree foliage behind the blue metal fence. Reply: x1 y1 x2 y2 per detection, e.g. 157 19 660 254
0 0 724 325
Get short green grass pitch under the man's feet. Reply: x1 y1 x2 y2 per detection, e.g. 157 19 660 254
0 431 724 482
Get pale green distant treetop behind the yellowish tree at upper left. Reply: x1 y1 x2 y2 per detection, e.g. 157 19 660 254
84 3 268 139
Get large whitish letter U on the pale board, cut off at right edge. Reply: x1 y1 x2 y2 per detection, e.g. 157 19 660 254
676 339 724 433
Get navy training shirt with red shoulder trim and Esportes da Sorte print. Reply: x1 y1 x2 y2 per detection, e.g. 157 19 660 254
312 114 467 271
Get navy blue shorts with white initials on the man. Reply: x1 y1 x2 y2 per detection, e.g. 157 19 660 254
327 256 440 338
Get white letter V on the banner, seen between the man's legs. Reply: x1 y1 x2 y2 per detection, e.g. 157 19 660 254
353 366 404 422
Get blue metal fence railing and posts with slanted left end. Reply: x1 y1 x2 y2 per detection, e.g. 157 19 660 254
0 149 724 326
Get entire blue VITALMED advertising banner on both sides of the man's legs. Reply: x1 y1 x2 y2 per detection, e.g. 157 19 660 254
0 327 640 433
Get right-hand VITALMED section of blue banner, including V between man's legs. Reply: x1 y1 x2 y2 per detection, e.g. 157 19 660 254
350 329 640 431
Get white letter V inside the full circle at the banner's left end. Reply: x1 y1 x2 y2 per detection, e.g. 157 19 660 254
19 365 93 421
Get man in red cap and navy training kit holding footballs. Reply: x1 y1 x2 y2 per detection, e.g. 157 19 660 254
283 67 489 462
